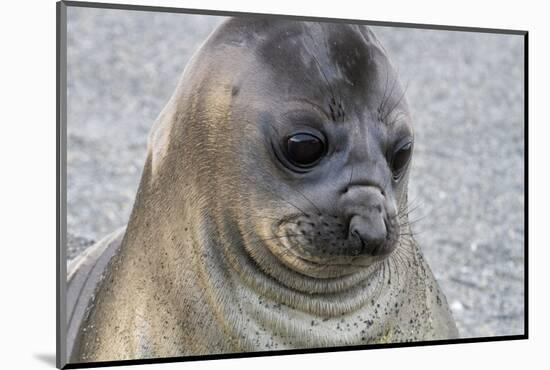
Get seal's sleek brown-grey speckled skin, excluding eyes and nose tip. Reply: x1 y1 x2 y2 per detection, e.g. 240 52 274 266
68 18 458 362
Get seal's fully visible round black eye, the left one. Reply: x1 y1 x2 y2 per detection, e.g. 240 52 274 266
286 133 325 167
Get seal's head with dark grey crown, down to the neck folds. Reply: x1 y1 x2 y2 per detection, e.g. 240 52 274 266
149 18 413 285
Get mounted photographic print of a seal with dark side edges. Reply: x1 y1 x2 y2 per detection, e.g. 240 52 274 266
58 2 527 367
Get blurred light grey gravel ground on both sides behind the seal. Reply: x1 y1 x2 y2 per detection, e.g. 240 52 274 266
67 8 525 337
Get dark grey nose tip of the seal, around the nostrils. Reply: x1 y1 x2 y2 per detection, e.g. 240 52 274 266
348 213 388 256
